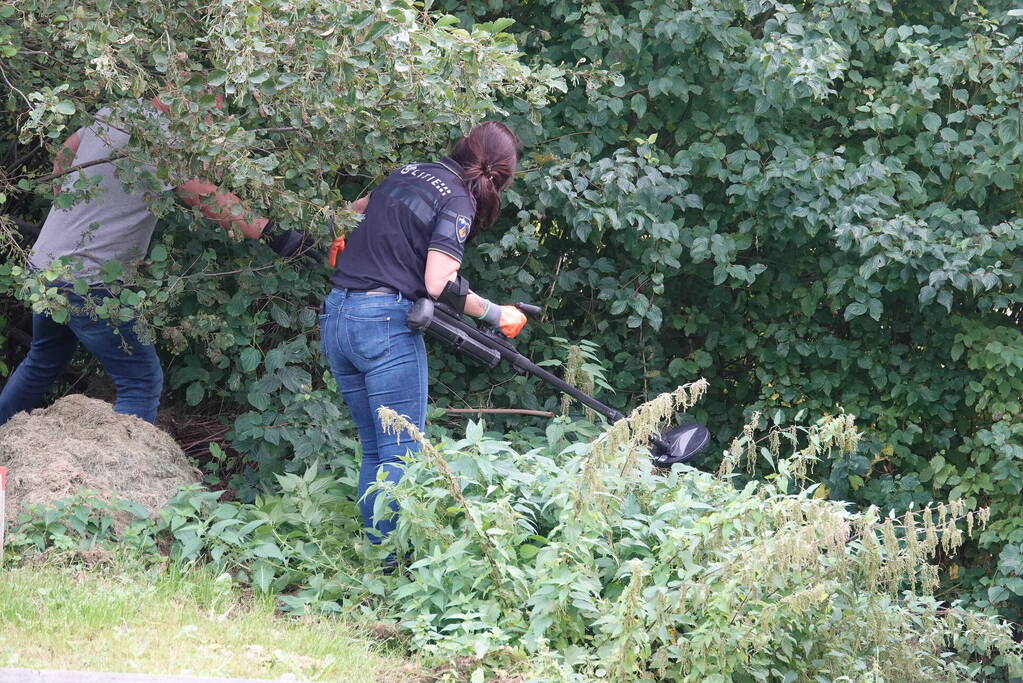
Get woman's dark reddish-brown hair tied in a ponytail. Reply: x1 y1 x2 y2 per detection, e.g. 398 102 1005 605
451 121 519 239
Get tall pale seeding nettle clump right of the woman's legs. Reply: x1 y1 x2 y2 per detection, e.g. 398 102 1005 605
372 381 1023 681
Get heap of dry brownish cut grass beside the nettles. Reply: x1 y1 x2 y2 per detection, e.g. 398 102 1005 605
0 395 198 521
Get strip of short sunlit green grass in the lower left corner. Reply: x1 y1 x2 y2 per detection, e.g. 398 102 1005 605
0 565 415 683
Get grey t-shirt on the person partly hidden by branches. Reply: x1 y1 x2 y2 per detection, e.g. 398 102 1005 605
29 102 173 283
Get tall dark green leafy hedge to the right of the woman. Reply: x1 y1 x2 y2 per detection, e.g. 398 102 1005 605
427 0 1023 620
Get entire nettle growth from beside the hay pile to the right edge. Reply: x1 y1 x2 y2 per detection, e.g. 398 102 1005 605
7 381 1023 682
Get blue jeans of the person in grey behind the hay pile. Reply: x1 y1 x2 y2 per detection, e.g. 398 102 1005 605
0 285 164 424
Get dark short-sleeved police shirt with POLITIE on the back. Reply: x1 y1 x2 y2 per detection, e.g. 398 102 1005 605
330 156 476 301
